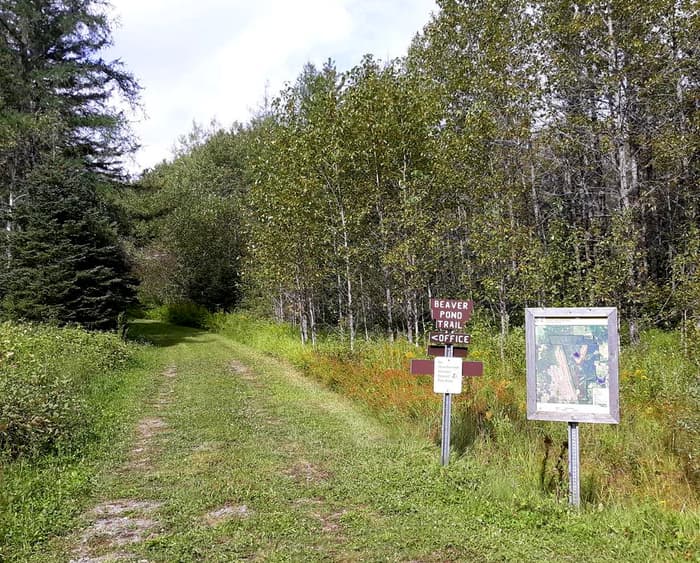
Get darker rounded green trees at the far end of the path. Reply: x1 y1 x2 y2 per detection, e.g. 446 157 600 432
125 123 249 311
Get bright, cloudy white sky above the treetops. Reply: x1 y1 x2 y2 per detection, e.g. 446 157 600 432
103 0 437 173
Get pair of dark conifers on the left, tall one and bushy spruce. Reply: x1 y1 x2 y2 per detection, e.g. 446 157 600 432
0 0 139 328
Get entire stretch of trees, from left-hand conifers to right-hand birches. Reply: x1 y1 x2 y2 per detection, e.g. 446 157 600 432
0 0 700 347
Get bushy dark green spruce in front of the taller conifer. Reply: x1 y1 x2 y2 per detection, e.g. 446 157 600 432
0 161 134 329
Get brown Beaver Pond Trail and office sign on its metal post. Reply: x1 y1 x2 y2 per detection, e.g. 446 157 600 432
411 299 484 465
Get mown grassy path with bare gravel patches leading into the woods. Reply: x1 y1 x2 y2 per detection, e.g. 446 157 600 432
5 322 700 562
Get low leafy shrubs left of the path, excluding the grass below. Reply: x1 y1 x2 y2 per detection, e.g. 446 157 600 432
0 322 130 458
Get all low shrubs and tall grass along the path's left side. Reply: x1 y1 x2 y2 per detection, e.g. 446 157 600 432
0 323 152 561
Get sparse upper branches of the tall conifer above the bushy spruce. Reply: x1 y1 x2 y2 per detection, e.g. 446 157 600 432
0 0 139 167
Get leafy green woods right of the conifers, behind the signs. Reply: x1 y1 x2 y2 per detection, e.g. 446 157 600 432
135 1 700 347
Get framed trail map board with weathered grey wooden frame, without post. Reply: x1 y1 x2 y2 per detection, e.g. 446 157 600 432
525 307 620 424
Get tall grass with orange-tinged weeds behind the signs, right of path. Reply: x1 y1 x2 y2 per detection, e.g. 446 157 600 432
211 314 700 510
